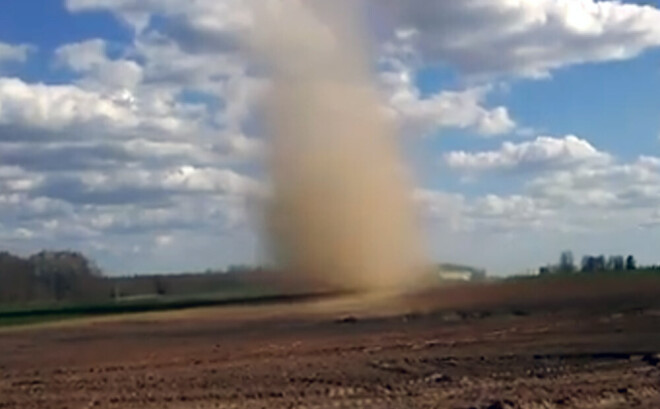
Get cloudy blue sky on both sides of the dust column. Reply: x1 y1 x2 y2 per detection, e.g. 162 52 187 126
0 0 660 273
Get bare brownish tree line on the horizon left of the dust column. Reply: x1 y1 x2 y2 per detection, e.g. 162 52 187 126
0 251 271 307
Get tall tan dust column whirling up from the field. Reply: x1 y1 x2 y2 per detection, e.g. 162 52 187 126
253 0 424 291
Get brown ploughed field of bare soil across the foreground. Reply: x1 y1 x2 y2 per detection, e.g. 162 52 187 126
0 279 660 409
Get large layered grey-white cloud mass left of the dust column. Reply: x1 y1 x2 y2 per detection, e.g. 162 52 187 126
0 25 263 264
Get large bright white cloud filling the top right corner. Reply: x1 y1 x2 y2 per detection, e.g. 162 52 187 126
382 0 660 77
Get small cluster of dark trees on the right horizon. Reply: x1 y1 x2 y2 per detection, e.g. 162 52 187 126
540 250 646 275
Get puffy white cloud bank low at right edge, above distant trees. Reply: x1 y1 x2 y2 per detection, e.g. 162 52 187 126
434 145 660 234
